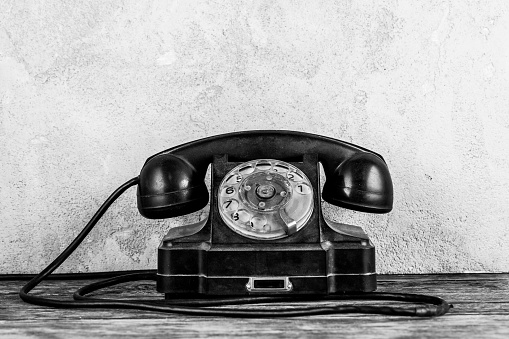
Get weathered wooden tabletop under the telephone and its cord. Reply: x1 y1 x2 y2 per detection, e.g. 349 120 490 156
0 274 509 338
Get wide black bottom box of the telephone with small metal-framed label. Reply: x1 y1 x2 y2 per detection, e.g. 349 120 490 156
157 242 376 298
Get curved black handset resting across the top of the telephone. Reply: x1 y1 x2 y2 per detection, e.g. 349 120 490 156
138 131 393 219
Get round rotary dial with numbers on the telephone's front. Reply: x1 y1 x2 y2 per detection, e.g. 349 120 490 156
218 159 314 240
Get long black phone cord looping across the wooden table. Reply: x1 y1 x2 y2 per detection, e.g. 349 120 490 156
19 177 453 318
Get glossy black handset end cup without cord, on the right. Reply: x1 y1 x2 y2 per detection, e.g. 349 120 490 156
323 152 393 213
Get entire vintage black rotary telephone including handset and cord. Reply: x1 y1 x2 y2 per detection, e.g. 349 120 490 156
20 131 450 317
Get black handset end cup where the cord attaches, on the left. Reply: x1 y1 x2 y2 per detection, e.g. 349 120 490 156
137 153 209 219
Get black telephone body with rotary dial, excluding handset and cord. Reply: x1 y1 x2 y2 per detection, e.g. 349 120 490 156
157 153 376 298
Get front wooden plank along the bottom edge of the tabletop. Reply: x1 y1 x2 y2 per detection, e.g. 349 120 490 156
0 315 509 338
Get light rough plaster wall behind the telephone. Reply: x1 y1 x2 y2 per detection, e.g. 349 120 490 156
0 0 509 273
